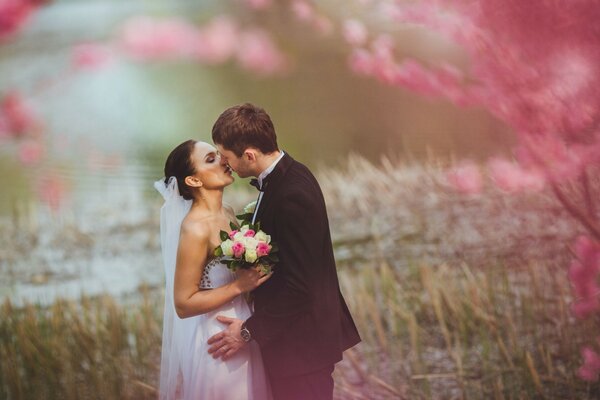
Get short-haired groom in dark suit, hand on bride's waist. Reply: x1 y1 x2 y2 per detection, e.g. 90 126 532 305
208 104 360 400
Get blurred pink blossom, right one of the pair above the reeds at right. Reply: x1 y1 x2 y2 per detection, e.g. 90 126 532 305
488 158 545 192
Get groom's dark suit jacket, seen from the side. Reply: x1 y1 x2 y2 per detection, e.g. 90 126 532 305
246 153 360 377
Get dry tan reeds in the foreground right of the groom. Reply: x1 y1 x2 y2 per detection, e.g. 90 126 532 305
336 260 600 399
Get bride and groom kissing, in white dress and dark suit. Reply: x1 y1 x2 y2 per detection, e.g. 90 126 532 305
154 104 360 400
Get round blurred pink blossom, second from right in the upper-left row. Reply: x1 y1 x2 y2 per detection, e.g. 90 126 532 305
194 16 239 64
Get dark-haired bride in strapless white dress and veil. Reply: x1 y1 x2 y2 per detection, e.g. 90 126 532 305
154 140 270 400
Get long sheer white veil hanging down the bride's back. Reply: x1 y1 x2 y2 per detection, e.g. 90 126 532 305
154 176 194 400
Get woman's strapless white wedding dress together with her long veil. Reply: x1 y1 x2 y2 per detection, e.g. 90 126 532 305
154 178 271 400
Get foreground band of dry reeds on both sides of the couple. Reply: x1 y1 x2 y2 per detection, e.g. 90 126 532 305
0 260 600 399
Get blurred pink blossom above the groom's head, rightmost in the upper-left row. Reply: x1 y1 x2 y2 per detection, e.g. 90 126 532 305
237 29 286 75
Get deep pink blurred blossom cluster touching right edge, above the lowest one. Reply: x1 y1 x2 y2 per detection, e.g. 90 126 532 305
569 236 600 319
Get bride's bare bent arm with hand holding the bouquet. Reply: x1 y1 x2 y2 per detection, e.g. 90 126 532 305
173 223 266 318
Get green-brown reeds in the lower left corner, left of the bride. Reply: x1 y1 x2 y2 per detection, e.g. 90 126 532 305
0 289 161 399
